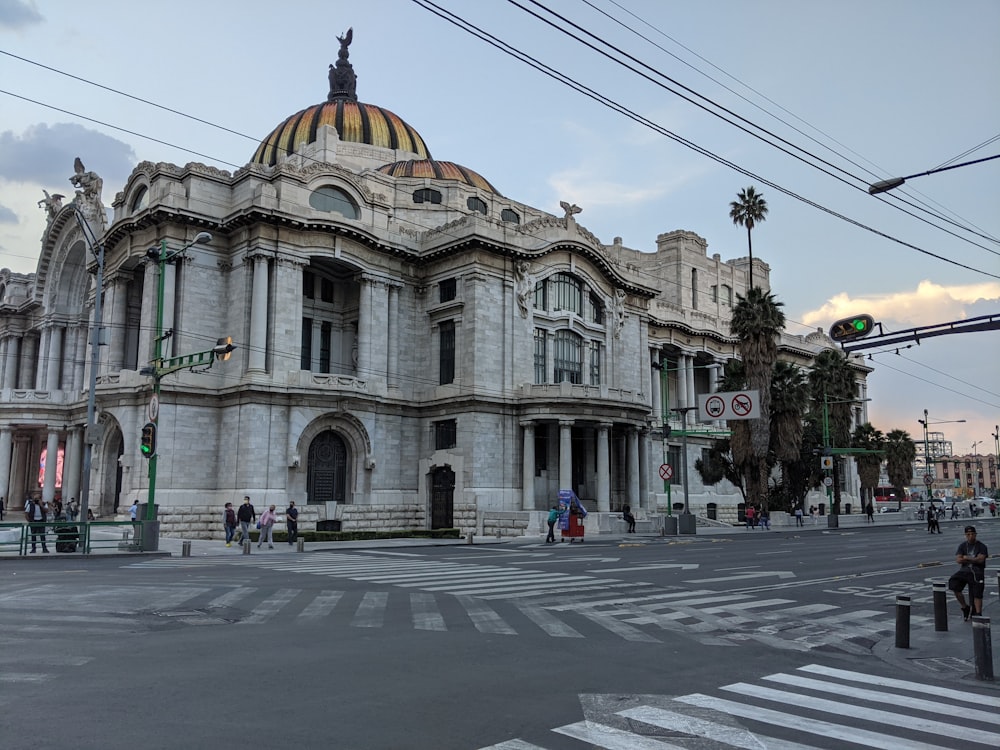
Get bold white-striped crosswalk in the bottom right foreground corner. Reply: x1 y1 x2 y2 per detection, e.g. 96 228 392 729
479 664 1000 750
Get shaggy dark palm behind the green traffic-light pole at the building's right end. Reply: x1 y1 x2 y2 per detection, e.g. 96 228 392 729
809 349 856 515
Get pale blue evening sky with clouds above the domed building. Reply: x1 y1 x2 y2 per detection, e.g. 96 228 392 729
0 0 1000 454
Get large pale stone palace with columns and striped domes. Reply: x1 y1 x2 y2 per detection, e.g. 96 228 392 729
0 35 867 534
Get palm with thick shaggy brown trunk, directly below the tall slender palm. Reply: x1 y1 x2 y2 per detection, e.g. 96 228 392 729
729 287 785 508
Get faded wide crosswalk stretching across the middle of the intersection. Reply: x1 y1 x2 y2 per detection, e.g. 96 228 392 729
115 552 927 654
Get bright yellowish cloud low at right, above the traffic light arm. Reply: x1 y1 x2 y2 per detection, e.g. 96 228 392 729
801 281 1000 328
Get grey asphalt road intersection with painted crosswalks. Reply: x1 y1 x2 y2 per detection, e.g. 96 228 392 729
0 523 1000 750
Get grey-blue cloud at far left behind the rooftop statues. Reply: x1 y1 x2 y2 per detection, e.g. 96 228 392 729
0 122 136 188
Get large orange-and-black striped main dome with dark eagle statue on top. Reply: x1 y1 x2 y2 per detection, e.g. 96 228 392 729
252 30 431 166
